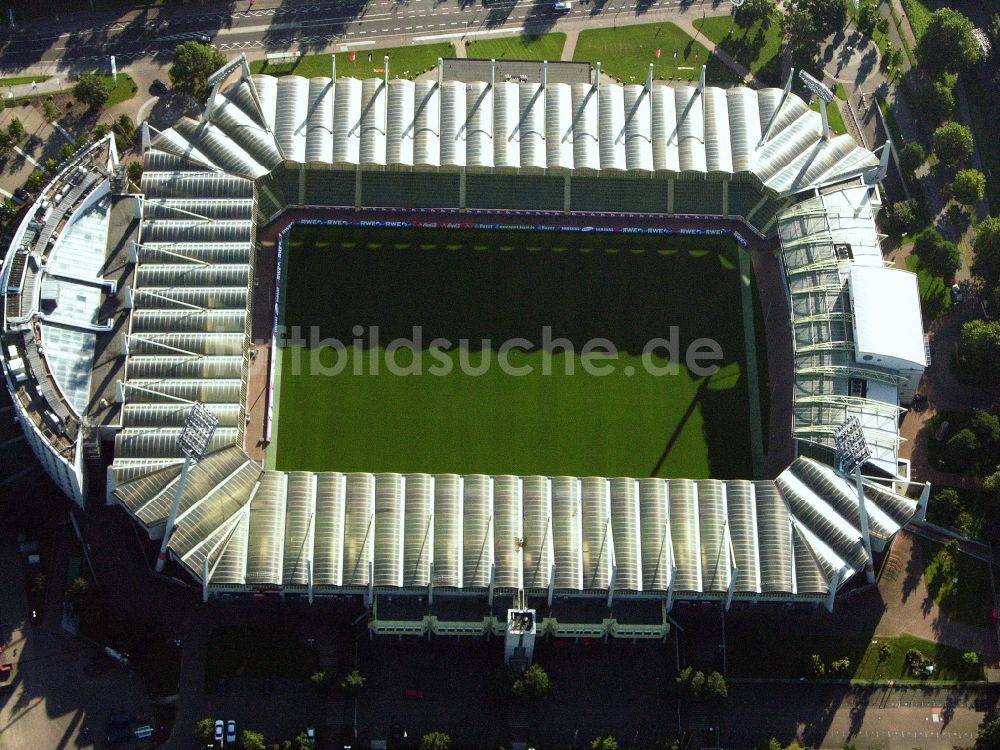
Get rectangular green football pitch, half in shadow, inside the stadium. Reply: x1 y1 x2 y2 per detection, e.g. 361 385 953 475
267 226 759 479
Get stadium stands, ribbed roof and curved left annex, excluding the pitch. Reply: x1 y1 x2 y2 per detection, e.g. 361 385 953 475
3 60 927 624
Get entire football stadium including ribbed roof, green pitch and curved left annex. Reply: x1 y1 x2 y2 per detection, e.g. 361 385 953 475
3 53 929 637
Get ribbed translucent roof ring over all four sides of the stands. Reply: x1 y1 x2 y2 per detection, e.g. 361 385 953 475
5 58 917 606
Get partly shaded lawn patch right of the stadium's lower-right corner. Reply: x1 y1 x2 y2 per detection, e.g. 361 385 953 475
921 539 993 625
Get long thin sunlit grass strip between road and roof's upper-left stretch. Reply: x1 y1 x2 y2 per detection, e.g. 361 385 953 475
250 42 455 79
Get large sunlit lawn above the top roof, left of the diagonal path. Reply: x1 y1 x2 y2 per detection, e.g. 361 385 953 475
573 23 738 83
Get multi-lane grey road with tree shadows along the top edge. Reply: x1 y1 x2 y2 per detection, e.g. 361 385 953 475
0 0 728 70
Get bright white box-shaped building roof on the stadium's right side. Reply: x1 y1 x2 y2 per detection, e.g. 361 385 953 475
849 265 927 369
